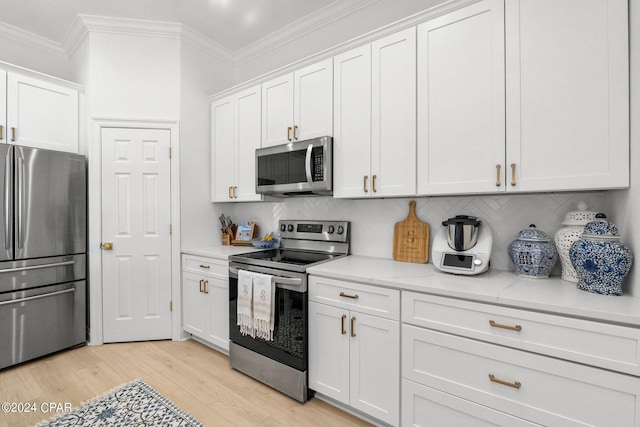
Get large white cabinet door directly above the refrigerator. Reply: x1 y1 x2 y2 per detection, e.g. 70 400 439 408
6 72 79 153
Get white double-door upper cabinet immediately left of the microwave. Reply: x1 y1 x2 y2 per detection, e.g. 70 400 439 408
211 86 262 202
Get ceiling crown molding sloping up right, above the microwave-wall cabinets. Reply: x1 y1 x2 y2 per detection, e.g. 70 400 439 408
234 0 381 66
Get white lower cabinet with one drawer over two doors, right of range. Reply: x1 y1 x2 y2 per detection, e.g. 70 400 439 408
309 276 400 425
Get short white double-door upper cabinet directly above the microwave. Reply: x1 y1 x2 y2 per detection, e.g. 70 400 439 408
262 59 333 147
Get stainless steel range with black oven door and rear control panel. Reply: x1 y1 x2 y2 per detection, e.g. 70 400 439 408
229 220 350 402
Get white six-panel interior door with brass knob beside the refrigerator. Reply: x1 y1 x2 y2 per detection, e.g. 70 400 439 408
102 128 171 342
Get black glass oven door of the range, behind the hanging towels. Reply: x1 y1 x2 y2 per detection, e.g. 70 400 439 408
229 262 309 371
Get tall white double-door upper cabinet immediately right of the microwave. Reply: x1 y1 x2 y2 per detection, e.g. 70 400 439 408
334 28 416 198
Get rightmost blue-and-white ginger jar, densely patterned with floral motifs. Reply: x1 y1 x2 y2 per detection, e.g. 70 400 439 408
569 214 633 295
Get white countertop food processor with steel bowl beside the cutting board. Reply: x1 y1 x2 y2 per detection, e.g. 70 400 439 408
431 215 493 275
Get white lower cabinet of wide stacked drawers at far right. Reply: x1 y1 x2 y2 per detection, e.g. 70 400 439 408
402 292 640 426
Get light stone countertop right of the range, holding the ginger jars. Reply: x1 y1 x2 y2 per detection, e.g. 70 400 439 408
307 255 640 327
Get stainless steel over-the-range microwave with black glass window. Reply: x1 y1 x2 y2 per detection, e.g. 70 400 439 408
256 136 333 197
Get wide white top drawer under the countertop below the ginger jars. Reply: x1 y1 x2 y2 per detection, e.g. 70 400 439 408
402 292 640 375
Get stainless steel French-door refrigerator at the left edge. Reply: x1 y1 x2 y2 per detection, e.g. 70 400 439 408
0 144 87 369
